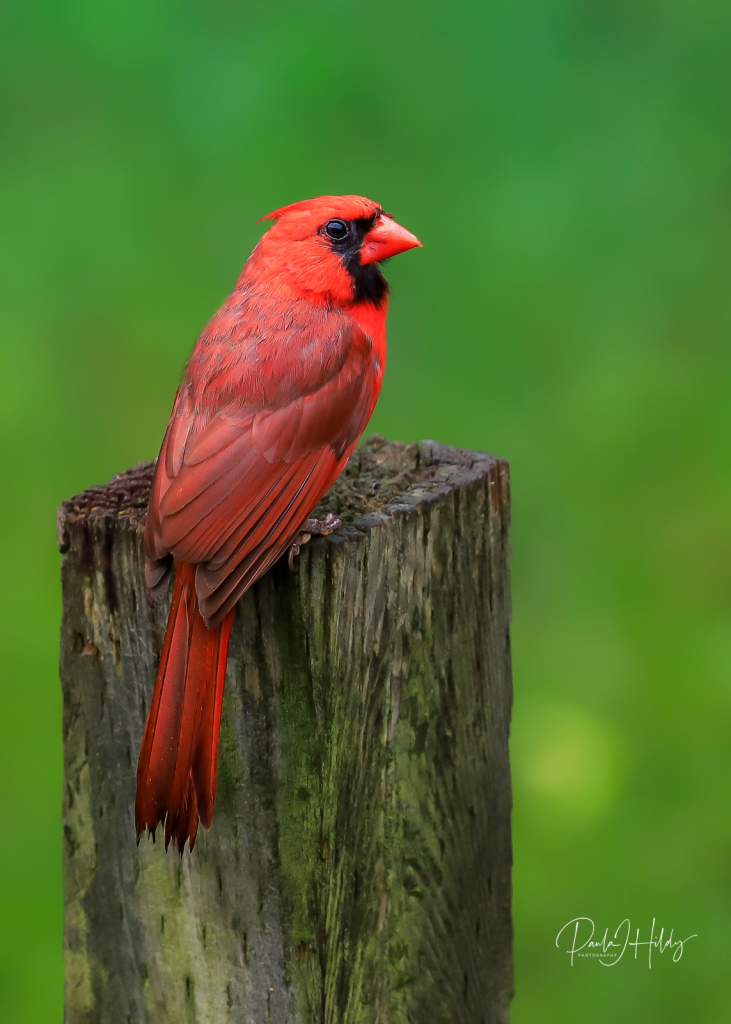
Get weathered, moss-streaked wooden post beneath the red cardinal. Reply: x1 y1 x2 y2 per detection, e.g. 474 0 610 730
58 437 513 1024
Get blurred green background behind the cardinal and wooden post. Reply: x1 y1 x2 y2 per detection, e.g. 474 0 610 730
0 0 731 1024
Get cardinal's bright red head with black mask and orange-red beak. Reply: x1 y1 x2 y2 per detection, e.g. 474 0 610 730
242 196 421 306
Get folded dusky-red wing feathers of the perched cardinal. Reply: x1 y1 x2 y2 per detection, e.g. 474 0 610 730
145 321 378 626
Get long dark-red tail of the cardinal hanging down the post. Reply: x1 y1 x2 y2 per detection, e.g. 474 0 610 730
134 562 233 854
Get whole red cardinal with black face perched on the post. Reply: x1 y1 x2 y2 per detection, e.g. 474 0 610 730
135 196 421 853
